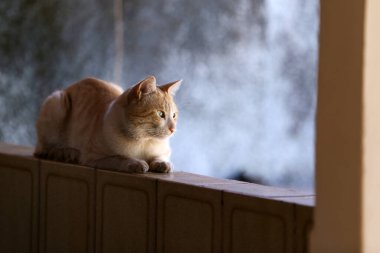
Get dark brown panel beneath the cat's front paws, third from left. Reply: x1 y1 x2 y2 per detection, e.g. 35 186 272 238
96 170 156 253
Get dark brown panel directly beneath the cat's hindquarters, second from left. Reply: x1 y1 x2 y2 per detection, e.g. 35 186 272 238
40 161 95 253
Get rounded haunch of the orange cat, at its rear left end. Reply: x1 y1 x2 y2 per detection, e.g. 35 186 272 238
34 90 71 157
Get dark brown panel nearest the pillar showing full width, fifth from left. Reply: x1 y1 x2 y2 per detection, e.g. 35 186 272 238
223 192 294 253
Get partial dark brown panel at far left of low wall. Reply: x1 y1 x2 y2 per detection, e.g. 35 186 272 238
0 154 38 253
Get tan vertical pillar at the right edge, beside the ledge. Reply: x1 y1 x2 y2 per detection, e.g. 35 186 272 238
310 0 380 253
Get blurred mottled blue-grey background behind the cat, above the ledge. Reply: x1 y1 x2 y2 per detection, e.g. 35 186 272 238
0 0 319 190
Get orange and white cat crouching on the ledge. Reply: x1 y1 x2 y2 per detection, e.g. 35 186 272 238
34 76 182 173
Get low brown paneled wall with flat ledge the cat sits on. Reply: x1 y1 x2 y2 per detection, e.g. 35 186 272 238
0 144 314 253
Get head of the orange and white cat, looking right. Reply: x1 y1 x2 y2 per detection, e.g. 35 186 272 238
122 76 181 138
